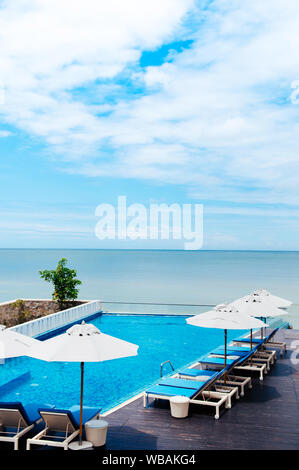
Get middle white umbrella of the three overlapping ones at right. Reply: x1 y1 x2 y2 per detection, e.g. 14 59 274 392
230 294 287 338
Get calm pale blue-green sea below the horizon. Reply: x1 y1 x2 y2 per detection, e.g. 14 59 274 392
0 250 299 306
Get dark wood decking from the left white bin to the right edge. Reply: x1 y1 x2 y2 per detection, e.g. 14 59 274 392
105 330 299 450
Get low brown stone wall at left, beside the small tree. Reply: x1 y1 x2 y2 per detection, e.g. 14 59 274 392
0 299 87 327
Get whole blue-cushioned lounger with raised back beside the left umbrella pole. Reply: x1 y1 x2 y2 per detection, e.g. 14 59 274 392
26 406 101 450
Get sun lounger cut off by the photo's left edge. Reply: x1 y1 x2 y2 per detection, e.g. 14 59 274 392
0 402 54 450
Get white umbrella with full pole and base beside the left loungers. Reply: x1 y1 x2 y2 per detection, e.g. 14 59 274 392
30 322 139 450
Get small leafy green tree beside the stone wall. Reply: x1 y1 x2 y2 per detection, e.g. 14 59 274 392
39 258 82 310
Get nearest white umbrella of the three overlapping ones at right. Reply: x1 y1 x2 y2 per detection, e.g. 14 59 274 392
186 304 264 378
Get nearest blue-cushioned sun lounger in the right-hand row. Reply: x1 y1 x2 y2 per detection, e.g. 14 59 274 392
143 371 238 419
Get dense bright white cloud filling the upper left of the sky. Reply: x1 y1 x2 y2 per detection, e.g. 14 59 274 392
0 0 193 149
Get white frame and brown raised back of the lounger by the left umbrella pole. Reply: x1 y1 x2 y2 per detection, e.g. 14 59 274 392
26 410 100 450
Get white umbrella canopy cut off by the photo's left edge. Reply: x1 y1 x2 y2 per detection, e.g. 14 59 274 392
0 325 40 359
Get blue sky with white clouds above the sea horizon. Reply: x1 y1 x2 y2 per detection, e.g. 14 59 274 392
0 0 299 250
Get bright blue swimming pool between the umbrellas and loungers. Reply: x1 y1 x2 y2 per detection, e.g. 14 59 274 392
0 314 288 412
